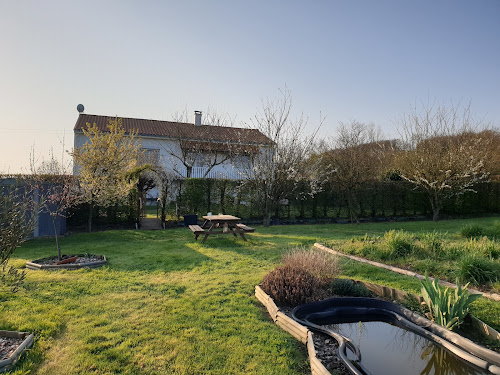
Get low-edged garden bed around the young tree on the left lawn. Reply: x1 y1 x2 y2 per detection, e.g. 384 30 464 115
26 254 106 270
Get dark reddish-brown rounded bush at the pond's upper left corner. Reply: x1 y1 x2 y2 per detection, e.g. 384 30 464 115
262 266 325 306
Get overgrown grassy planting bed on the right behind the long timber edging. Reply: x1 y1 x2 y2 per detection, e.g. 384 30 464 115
327 220 500 292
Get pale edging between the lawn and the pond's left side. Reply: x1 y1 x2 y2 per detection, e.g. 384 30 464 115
255 285 330 375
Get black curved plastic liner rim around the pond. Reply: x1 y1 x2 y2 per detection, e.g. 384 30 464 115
292 297 500 375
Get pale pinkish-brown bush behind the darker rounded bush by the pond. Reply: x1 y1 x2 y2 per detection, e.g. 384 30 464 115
283 247 340 279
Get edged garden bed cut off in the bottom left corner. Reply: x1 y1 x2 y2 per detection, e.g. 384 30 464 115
0 331 33 372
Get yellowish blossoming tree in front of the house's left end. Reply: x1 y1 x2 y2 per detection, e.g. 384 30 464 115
72 118 139 232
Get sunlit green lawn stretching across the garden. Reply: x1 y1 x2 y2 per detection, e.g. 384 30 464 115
0 218 500 374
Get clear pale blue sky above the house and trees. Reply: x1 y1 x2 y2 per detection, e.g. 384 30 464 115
0 0 500 172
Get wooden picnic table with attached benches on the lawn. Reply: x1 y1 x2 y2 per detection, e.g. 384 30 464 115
189 215 255 243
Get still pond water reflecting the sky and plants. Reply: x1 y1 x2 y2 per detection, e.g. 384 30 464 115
327 321 488 375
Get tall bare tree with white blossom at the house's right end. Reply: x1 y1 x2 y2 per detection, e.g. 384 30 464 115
243 88 322 226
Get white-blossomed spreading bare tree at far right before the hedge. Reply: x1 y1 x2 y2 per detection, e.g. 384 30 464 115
397 104 492 221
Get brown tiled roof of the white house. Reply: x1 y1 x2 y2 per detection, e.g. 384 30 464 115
73 113 273 145
